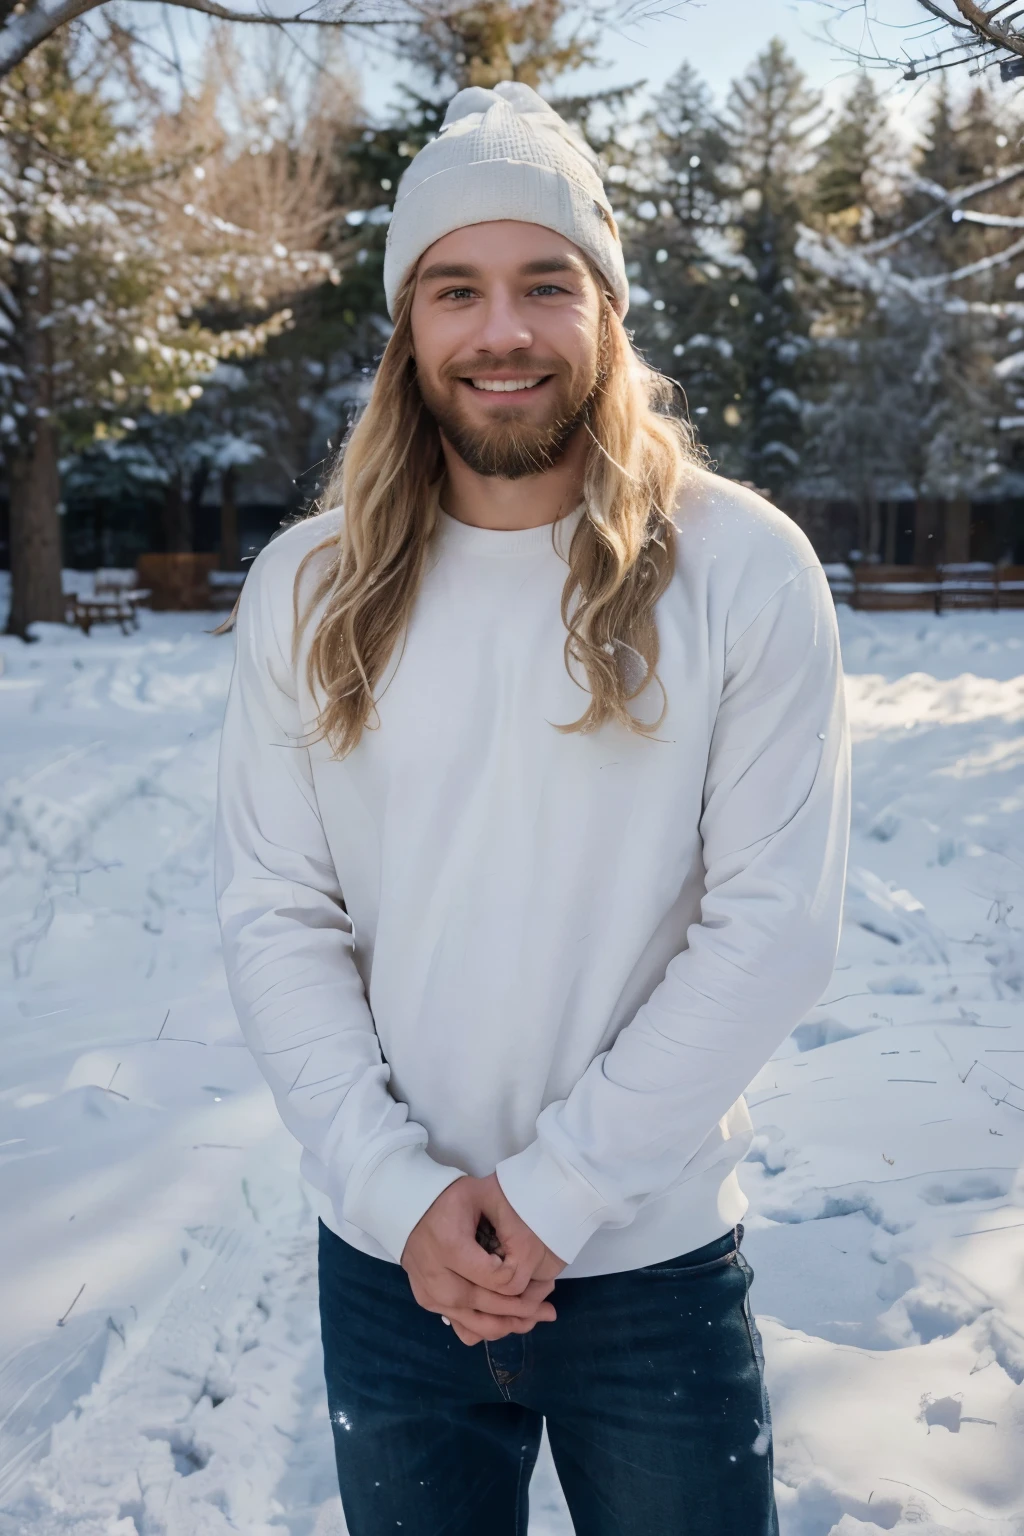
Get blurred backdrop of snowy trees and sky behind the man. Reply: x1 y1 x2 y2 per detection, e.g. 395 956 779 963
0 0 1024 634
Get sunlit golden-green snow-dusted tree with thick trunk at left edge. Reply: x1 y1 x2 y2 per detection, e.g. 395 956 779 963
0 32 343 636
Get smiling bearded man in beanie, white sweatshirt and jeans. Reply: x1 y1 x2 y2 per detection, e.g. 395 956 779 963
218 84 849 1536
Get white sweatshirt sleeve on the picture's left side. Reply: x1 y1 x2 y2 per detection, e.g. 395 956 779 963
215 545 462 1261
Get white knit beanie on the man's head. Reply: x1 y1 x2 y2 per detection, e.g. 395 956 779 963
384 80 629 316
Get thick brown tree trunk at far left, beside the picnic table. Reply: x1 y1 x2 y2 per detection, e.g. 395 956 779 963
8 421 64 641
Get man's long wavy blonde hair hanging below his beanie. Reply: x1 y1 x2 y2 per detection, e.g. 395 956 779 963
295 270 699 756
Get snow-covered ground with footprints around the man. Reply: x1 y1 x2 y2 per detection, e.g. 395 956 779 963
0 589 1024 1536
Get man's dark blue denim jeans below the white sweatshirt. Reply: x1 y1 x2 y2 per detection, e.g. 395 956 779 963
319 1223 778 1536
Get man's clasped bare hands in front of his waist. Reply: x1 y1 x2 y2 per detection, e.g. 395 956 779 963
402 1174 565 1344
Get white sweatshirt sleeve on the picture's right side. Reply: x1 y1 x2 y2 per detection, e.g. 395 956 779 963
497 565 849 1263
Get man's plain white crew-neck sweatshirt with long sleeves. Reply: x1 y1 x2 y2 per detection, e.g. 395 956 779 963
216 472 849 1276
